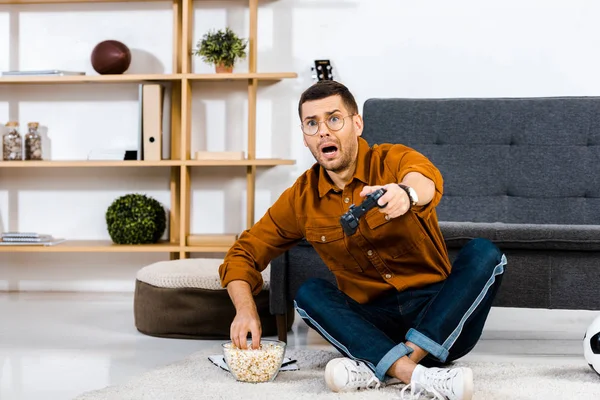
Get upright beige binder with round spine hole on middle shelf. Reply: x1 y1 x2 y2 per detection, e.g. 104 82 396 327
142 84 164 161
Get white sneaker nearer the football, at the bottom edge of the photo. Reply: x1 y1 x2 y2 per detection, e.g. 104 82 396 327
400 365 473 400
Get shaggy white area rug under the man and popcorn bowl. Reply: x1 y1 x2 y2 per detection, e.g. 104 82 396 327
76 347 600 400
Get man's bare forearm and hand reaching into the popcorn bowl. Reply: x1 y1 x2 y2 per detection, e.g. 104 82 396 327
227 281 262 349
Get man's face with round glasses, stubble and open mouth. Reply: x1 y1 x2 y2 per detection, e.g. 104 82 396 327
302 95 362 173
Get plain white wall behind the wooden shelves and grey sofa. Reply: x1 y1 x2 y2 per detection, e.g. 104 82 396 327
0 0 600 291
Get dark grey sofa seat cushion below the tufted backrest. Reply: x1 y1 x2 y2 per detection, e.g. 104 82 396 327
440 221 600 251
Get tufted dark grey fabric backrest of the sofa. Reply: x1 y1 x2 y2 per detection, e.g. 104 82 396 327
363 97 600 224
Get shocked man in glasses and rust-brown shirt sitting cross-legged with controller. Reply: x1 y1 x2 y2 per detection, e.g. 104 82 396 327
219 81 506 400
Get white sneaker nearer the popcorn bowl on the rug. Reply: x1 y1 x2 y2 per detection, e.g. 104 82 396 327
325 358 381 392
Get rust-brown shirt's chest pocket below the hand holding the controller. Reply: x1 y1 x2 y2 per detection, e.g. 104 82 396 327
365 209 426 258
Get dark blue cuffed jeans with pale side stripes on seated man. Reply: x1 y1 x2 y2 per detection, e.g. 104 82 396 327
294 239 506 380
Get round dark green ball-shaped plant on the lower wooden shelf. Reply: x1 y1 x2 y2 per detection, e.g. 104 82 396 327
106 194 167 244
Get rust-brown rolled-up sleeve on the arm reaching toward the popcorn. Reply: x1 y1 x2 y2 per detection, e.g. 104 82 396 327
219 185 303 295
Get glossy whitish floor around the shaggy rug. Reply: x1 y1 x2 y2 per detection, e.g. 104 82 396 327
0 293 600 400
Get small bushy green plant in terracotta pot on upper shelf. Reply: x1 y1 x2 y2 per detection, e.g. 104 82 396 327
194 28 248 73
